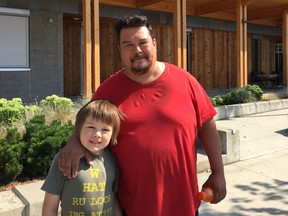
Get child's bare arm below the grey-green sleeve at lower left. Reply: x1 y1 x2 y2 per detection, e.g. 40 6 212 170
42 192 60 216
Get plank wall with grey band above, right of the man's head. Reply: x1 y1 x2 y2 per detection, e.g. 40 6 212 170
187 16 282 90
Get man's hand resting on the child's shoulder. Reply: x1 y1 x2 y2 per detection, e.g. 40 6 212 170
58 134 92 178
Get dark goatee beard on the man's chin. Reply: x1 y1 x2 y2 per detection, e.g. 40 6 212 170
130 54 152 75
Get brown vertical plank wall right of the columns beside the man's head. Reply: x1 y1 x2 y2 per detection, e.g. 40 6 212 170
191 28 281 89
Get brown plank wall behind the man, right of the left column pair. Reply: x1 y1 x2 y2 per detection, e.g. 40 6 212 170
96 18 281 89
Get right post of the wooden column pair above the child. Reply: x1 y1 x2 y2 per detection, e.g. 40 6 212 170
92 0 100 94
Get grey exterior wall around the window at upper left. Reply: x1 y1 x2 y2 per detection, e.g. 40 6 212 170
0 11 63 102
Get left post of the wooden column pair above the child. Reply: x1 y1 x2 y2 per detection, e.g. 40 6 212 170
82 0 92 98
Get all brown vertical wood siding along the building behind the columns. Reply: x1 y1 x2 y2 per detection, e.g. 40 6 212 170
64 18 281 95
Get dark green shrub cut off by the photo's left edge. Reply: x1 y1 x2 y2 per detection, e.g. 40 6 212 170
0 129 25 184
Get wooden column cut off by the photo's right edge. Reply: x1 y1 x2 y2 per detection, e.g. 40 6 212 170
282 9 288 88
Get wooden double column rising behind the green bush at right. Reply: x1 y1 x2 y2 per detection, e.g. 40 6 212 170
236 0 248 87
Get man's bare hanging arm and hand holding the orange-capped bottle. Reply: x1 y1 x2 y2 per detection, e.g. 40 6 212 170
198 119 227 203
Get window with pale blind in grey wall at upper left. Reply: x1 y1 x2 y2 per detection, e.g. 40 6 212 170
0 7 30 71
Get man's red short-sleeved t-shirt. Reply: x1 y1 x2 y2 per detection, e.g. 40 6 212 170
93 63 216 216
